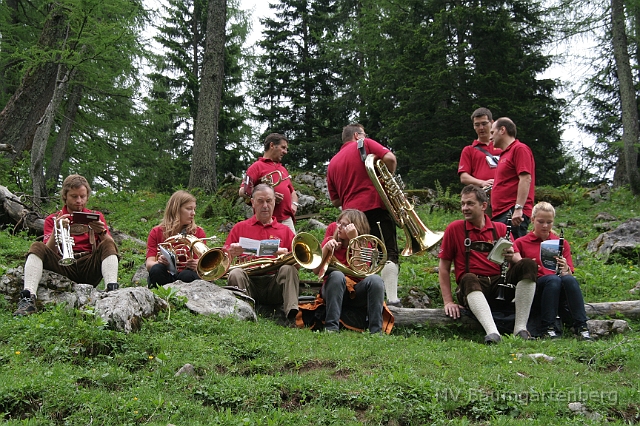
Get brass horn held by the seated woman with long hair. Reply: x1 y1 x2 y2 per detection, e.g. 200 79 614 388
160 234 231 281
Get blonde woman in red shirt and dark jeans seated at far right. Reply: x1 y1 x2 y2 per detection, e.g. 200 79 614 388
515 201 591 340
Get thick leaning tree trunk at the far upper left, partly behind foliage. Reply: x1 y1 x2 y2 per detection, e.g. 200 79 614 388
0 6 66 163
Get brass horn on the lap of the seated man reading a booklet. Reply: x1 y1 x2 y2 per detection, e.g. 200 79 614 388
229 232 322 276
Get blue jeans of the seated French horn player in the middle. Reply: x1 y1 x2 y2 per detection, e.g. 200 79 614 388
320 271 384 333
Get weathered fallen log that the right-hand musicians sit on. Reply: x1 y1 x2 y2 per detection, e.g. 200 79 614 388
389 300 640 329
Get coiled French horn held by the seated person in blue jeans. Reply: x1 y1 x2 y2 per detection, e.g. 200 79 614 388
314 234 387 278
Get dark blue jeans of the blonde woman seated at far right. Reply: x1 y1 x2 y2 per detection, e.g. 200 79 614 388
536 274 587 329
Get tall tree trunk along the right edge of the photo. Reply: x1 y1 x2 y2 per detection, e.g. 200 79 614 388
611 0 640 195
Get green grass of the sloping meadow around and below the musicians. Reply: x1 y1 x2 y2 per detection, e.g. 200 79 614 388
0 185 640 425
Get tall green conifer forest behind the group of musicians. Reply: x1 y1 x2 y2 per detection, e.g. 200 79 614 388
0 0 640 196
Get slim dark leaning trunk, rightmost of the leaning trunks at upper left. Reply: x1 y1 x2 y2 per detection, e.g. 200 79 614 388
45 80 82 195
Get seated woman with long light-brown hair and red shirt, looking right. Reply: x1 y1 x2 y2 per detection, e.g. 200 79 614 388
146 191 206 288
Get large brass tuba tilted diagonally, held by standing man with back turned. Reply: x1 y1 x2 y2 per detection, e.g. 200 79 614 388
364 154 444 256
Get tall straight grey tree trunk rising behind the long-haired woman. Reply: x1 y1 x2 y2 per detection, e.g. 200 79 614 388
189 0 227 194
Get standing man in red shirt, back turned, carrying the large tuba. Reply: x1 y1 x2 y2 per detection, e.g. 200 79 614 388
327 123 401 306
